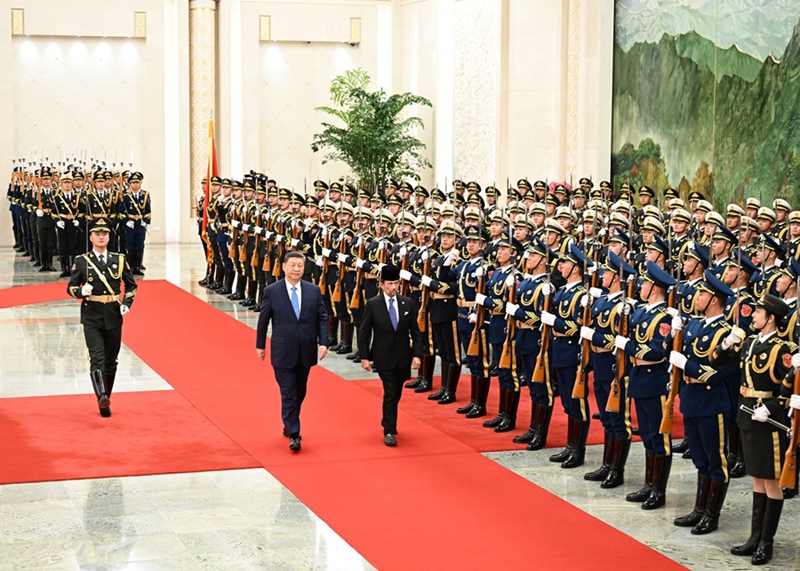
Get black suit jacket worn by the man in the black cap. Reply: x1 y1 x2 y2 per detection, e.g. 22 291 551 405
358 293 422 371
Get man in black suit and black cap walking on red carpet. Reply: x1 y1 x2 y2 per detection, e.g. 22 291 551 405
358 266 422 446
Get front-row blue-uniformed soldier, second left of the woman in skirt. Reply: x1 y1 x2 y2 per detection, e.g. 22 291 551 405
614 261 676 510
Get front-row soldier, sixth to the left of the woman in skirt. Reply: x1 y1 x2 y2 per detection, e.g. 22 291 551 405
475 232 522 432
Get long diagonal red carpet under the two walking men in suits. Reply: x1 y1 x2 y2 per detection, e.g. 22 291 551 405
1 282 680 570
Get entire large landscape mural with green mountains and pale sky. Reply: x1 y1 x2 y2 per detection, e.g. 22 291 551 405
612 0 800 209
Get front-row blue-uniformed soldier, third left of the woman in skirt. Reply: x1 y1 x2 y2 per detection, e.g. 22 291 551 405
581 252 635 488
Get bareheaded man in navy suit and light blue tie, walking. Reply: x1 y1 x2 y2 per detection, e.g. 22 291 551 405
256 252 328 452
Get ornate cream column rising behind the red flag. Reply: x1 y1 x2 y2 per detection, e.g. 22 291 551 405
189 0 217 204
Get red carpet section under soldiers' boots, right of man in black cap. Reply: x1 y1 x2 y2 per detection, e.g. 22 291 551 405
355 375 683 452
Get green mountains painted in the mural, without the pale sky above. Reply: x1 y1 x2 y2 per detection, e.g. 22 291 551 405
613 19 800 206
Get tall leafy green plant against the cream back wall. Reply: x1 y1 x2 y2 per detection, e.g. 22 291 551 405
311 68 432 190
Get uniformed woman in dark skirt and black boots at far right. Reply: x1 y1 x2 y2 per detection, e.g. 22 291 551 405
711 294 800 565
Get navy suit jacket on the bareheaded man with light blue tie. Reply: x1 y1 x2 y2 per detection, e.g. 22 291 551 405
256 279 328 369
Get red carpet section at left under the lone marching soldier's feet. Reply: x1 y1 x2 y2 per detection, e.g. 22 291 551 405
0 392 260 484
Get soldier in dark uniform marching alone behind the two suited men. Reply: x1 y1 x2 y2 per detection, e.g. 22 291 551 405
67 218 136 417
